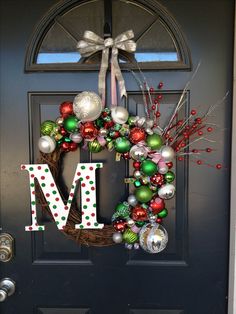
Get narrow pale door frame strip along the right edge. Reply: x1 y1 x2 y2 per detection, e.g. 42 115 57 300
228 3 236 314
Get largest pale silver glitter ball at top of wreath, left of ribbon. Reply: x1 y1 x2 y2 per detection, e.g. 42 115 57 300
73 92 103 122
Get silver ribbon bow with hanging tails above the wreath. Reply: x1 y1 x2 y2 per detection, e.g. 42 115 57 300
77 30 136 98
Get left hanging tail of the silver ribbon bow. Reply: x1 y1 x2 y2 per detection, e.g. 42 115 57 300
98 48 109 106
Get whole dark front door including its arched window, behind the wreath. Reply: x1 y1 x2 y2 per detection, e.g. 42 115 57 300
0 0 234 314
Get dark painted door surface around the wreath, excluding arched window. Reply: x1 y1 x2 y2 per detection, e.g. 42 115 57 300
0 0 234 314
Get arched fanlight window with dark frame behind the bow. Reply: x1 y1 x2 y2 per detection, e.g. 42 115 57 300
25 0 191 71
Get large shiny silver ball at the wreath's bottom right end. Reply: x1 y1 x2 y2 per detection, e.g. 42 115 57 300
139 223 168 254
